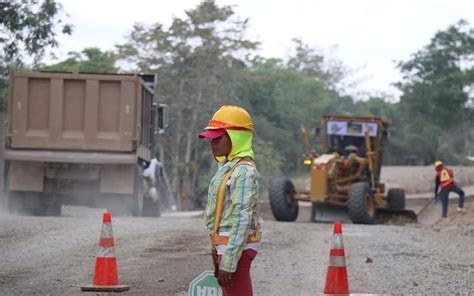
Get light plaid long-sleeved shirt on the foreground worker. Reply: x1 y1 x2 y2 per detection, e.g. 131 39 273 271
204 158 260 272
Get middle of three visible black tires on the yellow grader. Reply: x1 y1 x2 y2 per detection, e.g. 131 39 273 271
347 182 377 224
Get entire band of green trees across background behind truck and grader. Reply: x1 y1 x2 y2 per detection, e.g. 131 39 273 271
0 0 474 209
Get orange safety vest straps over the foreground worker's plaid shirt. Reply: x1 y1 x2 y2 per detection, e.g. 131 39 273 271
211 158 261 245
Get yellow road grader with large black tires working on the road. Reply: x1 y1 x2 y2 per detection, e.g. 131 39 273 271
269 115 416 224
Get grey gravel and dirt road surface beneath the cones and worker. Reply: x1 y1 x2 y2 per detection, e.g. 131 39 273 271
0 165 474 295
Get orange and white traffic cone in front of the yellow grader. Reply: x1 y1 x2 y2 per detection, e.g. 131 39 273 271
324 222 349 294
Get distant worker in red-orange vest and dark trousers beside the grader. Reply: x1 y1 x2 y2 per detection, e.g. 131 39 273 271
433 160 464 218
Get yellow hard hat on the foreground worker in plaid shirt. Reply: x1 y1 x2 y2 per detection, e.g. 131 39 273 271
205 105 254 131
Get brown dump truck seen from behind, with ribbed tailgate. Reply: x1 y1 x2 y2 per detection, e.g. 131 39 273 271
4 72 167 216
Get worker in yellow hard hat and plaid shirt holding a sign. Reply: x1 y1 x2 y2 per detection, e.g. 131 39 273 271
199 106 260 296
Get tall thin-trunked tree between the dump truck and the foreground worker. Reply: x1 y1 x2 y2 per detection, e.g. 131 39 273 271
118 0 257 209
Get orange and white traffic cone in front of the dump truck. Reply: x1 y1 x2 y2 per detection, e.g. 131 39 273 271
81 212 130 292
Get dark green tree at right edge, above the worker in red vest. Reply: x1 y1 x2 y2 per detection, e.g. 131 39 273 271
398 20 474 161
